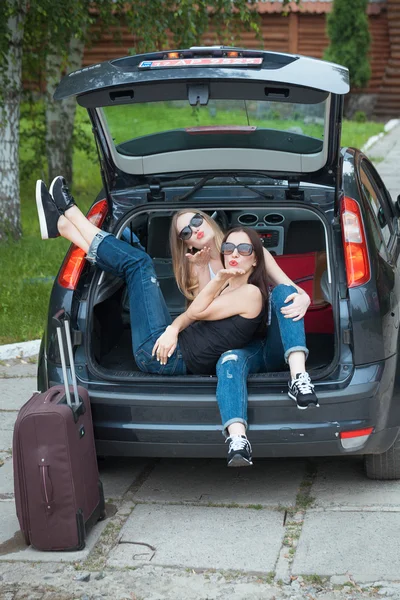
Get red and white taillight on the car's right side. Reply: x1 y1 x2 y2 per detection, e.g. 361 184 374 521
341 196 371 287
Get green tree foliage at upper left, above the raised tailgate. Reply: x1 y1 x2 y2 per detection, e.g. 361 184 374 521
0 0 300 238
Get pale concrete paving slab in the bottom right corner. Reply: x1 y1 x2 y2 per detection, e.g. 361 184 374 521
292 510 400 582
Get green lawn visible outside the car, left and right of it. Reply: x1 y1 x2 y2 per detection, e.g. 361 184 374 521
0 108 383 344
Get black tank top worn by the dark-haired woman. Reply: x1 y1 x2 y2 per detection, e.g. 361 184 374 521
178 307 265 375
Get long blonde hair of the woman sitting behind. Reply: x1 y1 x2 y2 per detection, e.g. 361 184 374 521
169 208 224 302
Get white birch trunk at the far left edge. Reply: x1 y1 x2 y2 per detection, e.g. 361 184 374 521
0 0 27 241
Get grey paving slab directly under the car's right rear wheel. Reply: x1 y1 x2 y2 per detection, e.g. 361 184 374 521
311 458 400 508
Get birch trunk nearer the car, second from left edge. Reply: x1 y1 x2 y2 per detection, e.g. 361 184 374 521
45 38 84 185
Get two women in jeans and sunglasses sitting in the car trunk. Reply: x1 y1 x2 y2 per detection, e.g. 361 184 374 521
36 177 317 466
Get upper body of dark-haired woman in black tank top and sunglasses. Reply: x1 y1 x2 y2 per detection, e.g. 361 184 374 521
153 228 268 374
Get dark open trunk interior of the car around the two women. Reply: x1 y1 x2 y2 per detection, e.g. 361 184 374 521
90 202 335 378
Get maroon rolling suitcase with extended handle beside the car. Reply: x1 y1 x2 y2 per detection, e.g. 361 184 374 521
13 311 105 550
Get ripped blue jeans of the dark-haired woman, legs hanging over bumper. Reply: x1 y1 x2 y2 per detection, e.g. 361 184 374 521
217 285 308 436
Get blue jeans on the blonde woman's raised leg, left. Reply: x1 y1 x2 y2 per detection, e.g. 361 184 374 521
87 231 186 375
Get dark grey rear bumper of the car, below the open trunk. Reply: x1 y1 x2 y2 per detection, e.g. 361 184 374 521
44 356 400 458
